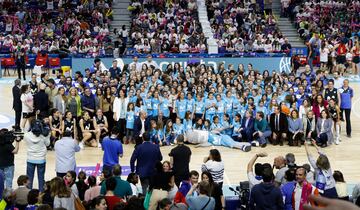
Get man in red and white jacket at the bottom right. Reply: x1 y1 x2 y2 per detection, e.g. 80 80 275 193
292 167 319 210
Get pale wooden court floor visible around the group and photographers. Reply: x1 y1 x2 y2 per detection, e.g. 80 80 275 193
0 79 360 186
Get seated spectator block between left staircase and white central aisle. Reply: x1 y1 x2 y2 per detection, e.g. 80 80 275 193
129 0 207 53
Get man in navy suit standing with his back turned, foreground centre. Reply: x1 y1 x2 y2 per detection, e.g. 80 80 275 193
130 133 162 195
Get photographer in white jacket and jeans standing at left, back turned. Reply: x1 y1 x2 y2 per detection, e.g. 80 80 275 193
24 120 50 192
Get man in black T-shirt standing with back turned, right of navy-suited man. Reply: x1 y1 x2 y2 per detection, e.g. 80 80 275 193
169 134 191 186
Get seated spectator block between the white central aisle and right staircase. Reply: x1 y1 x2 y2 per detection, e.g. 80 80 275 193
206 0 291 52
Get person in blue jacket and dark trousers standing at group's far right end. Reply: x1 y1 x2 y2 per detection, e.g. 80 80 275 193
339 79 354 138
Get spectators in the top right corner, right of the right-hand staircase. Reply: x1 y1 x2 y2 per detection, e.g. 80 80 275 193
281 0 360 75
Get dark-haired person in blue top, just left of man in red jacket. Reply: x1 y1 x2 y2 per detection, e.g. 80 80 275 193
280 168 296 210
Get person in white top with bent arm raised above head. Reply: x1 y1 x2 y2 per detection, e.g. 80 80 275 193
247 153 267 189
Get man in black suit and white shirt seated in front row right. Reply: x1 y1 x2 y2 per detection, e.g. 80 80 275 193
270 106 289 146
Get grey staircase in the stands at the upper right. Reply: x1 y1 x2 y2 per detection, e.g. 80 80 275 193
272 0 306 47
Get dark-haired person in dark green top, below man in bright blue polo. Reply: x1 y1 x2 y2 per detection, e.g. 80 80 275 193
100 164 132 199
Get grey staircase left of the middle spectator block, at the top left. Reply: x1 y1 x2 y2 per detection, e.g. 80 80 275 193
110 0 131 39
